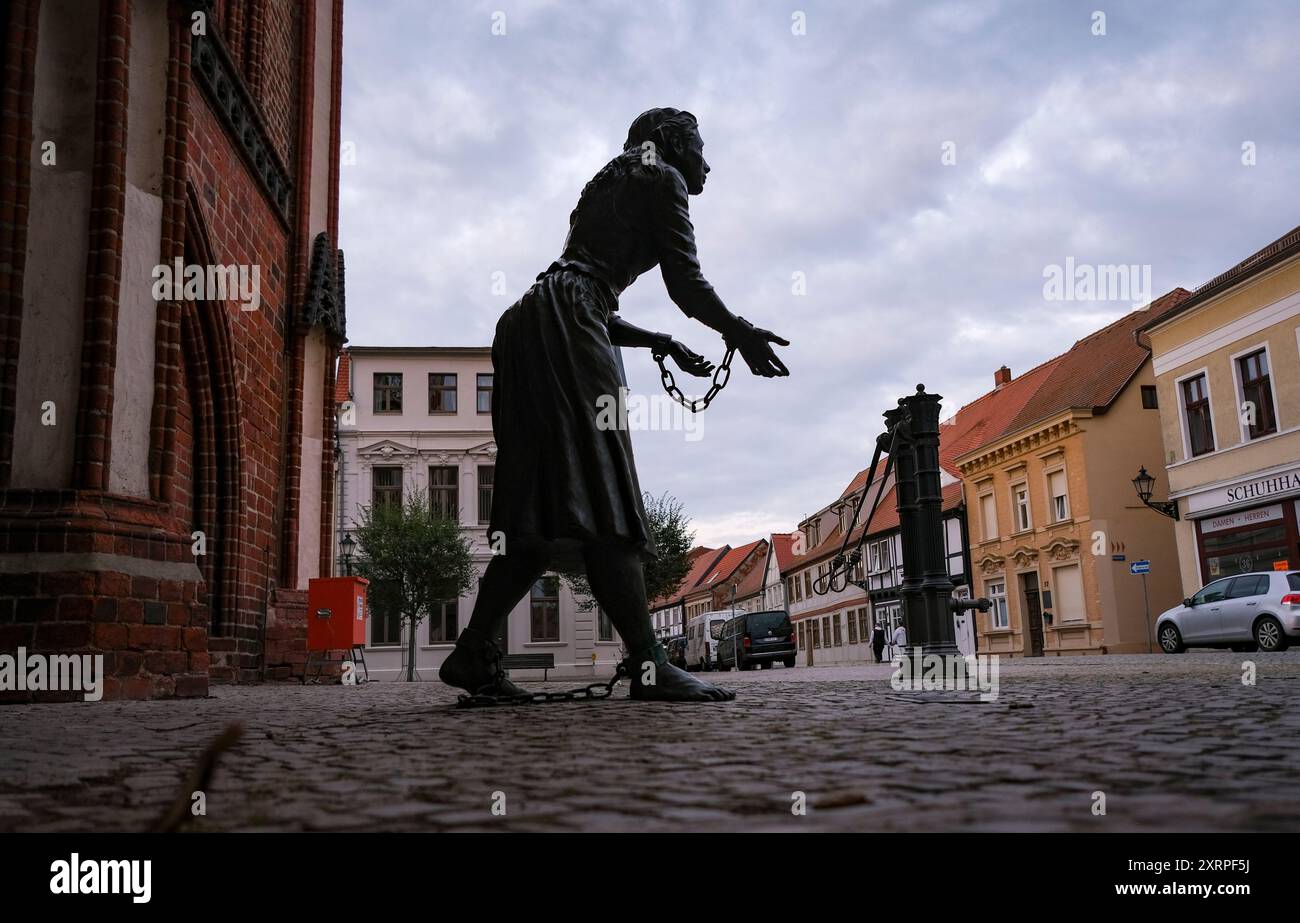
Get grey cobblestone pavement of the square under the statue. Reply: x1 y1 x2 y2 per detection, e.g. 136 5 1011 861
0 651 1300 832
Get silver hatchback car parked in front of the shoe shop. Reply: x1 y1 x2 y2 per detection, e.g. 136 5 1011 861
1156 571 1300 654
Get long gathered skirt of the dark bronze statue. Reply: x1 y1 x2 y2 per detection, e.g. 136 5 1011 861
489 269 655 569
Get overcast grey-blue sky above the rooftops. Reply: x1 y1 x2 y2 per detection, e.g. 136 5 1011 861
339 0 1300 545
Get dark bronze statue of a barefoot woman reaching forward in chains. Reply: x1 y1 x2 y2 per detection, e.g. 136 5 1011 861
438 109 789 701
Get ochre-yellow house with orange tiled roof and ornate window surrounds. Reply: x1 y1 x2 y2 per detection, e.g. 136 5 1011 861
956 289 1191 657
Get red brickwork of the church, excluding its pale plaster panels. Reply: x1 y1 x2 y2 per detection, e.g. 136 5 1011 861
0 0 337 701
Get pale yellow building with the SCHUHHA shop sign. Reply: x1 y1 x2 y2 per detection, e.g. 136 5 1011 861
1141 228 1300 595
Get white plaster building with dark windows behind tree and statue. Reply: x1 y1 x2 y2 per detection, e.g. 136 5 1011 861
333 346 619 680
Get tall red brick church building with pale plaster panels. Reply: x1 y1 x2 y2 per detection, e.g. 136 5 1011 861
0 0 345 699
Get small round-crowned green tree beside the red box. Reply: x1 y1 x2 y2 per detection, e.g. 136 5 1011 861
356 490 475 683
